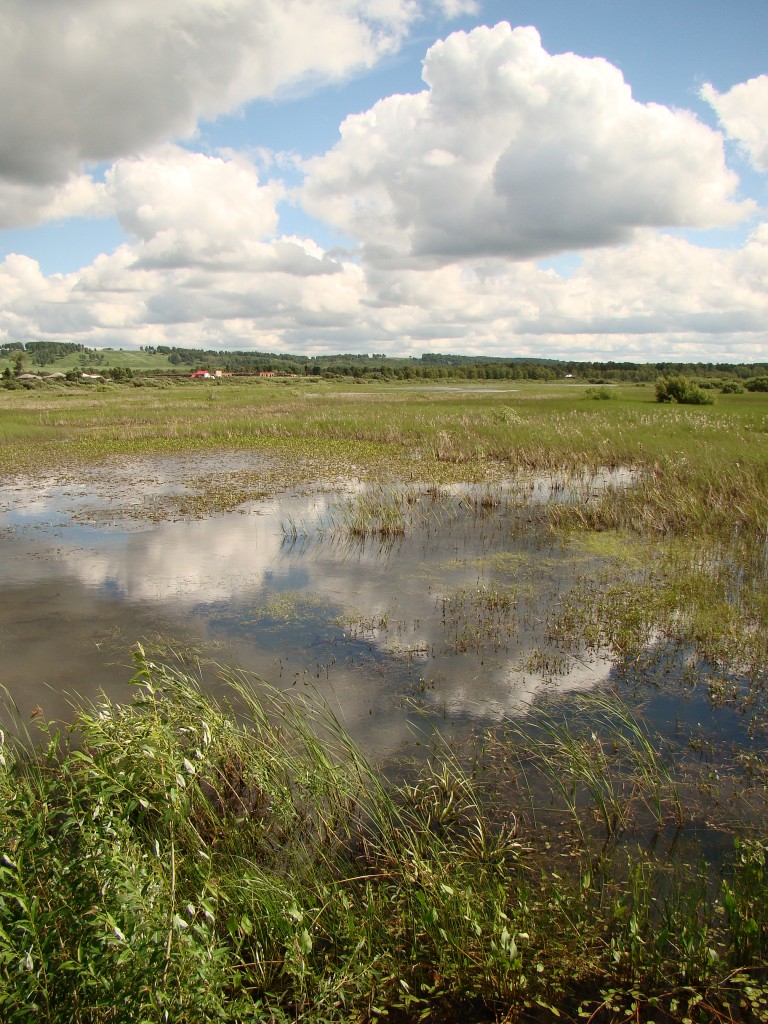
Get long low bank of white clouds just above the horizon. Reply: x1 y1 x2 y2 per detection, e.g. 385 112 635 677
0 225 768 361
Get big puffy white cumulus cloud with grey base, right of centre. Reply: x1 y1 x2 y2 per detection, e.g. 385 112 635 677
303 23 752 263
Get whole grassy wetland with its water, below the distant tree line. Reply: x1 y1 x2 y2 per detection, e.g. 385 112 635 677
0 381 768 1021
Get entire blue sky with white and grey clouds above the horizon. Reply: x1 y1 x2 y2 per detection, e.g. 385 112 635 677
0 0 768 362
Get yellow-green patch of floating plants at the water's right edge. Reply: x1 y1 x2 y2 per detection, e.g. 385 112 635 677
549 535 768 728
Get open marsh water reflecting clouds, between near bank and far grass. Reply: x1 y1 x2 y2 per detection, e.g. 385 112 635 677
0 457 757 758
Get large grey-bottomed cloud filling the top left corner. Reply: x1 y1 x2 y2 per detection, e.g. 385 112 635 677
0 0 428 226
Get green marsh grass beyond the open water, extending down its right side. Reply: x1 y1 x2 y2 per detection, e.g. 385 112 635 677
0 379 768 717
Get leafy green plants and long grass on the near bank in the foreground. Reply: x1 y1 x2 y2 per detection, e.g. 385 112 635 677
0 655 768 1024
